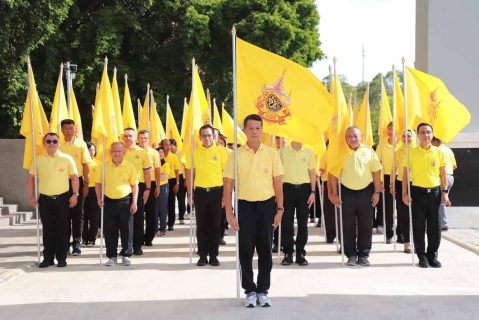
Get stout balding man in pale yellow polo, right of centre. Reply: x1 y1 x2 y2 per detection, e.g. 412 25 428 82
328 126 382 266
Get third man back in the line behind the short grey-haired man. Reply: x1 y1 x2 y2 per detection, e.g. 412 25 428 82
138 130 161 247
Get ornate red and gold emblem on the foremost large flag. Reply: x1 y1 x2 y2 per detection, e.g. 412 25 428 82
256 70 291 124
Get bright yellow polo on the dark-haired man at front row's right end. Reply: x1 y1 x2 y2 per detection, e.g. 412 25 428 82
402 146 446 188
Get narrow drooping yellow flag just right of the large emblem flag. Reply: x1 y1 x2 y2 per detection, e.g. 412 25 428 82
328 75 351 177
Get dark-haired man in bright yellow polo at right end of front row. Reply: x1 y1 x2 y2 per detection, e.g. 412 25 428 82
402 123 451 268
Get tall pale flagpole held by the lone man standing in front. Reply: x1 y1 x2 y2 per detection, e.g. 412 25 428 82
231 26 240 307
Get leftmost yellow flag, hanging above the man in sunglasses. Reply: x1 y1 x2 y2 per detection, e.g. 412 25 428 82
20 59 48 170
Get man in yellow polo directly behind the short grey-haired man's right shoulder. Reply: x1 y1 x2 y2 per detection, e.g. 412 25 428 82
122 128 152 255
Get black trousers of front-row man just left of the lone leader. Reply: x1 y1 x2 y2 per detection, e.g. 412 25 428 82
193 188 224 257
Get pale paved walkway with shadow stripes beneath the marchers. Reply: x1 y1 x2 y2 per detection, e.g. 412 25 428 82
0 222 479 320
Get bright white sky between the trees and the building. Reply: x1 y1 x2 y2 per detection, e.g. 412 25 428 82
311 0 416 86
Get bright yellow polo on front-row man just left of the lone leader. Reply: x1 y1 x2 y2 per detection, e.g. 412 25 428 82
185 144 228 188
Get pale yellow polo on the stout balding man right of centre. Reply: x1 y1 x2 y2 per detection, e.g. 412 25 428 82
341 144 382 190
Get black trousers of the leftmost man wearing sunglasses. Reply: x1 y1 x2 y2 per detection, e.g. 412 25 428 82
38 192 70 262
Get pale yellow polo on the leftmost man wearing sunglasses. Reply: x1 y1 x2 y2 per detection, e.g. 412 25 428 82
29 151 78 196
